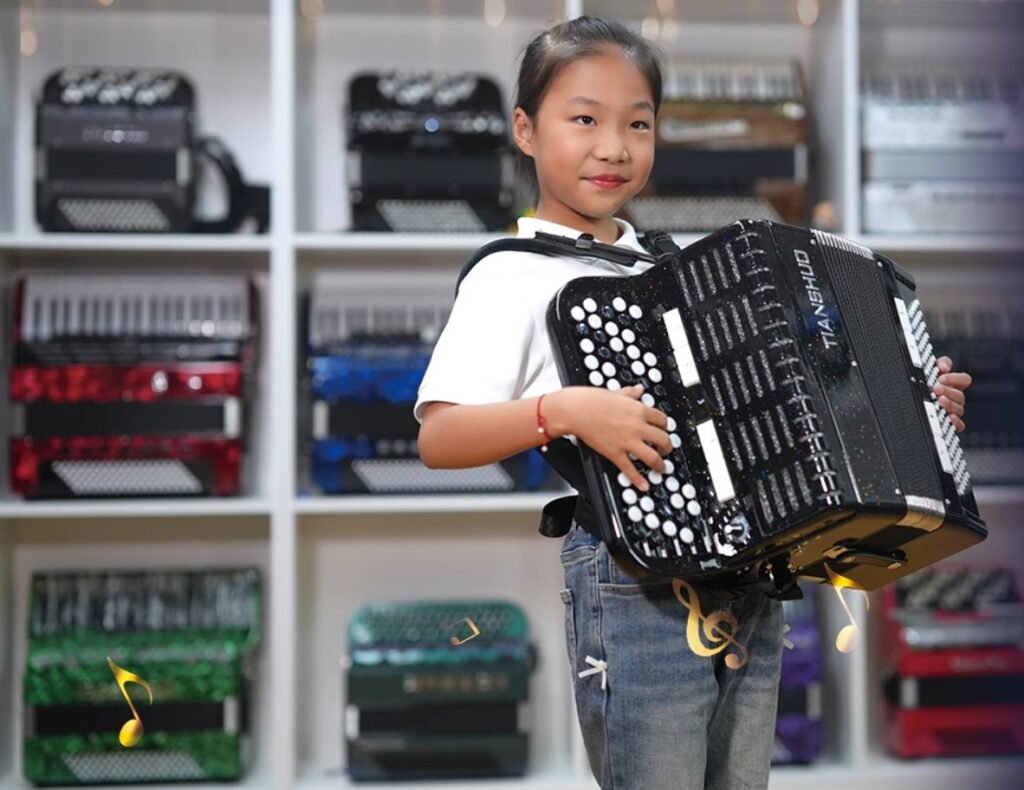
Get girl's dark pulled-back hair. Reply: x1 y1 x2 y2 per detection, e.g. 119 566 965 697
513 16 662 186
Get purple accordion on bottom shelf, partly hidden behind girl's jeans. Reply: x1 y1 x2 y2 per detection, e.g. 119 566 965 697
772 589 824 765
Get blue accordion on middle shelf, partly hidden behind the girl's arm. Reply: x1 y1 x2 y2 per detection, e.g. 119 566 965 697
307 272 558 494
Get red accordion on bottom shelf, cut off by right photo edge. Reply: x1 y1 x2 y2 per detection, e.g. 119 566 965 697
883 567 1024 757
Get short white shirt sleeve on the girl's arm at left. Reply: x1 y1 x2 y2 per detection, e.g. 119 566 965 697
413 255 536 422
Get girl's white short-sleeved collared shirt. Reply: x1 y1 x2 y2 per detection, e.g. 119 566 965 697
413 217 653 422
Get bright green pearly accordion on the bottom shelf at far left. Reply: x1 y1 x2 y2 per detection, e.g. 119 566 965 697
24 568 262 785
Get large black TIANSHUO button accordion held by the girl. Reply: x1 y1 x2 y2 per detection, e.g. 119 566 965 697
548 220 987 590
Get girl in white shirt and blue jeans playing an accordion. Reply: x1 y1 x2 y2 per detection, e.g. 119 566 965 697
415 16 970 790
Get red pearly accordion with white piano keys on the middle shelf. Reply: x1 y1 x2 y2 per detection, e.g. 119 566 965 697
10 273 258 498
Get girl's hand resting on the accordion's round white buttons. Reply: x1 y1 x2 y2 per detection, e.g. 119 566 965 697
562 384 672 491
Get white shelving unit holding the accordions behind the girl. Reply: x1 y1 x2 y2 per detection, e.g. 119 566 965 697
0 0 1024 790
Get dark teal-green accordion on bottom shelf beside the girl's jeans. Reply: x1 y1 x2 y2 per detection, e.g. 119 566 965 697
343 600 537 780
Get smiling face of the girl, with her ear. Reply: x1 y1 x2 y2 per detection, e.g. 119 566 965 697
512 49 654 241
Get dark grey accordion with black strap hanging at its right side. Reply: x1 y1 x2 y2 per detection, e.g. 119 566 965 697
36 69 269 233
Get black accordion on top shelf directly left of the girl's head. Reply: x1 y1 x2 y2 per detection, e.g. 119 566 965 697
346 72 513 233
